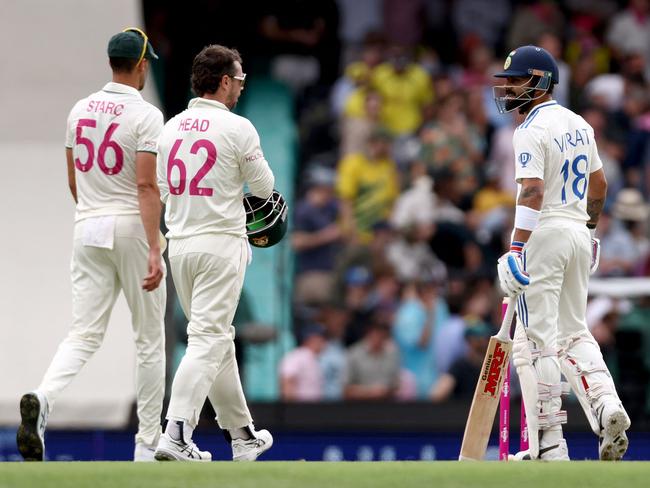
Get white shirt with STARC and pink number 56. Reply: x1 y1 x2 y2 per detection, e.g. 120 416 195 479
65 82 163 221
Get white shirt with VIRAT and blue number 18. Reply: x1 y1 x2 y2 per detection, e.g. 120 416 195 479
513 100 603 222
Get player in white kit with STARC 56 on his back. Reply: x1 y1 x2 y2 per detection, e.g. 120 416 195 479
17 28 166 461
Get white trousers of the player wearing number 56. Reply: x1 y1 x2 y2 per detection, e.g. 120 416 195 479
38 215 167 446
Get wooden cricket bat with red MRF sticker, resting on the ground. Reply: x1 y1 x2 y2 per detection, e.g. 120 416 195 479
458 298 516 461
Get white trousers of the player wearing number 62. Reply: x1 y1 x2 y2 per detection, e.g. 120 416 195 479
167 234 252 430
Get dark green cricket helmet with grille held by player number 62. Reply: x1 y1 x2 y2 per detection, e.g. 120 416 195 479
244 190 287 247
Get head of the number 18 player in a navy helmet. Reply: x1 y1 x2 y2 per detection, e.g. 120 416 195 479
493 46 560 114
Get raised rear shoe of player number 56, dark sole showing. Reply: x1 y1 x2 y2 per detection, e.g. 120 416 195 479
16 391 50 461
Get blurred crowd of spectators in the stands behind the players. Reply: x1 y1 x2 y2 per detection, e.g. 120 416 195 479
278 0 650 411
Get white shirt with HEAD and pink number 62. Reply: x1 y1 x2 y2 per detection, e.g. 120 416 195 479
158 98 275 239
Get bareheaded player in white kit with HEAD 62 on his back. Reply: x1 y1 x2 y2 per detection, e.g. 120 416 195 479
155 45 274 461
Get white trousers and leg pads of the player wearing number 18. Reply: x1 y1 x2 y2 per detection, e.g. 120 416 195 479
513 218 618 447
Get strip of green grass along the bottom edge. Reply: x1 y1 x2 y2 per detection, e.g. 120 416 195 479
0 461 650 488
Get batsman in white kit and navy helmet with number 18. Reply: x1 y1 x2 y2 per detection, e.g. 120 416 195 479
494 46 630 460
